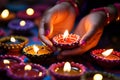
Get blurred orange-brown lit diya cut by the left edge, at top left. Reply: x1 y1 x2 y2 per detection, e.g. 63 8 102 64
0 9 15 21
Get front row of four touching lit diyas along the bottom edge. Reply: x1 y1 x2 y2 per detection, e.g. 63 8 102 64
0 55 119 80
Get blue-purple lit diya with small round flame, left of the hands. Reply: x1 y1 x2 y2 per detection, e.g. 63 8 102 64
8 19 35 35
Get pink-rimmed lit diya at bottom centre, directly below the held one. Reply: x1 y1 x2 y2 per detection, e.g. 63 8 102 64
48 62 86 80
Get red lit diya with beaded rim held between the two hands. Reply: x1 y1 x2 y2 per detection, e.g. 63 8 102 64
52 30 80 49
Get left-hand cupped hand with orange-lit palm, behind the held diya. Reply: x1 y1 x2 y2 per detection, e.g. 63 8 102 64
39 2 76 48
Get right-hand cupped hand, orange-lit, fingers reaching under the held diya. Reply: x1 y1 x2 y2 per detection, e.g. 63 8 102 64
58 11 106 58
